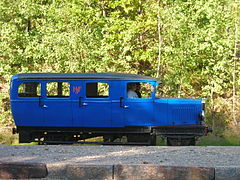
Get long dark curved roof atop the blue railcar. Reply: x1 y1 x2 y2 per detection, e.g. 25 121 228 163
16 73 156 81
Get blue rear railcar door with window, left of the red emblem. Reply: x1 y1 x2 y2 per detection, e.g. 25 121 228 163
41 80 73 127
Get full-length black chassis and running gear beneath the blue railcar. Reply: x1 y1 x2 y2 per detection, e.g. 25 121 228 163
13 126 206 146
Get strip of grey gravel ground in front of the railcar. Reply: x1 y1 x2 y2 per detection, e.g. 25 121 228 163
0 145 240 167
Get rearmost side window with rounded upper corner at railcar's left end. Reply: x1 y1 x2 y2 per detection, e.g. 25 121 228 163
18 82 41 97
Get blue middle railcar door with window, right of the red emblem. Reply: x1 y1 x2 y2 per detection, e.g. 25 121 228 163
77 80 111 127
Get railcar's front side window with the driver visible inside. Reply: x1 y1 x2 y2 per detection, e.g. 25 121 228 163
127 82 154 99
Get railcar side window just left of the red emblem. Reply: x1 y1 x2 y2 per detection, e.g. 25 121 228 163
47 82 70 98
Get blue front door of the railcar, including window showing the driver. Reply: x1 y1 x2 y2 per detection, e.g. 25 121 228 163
122 82 153 126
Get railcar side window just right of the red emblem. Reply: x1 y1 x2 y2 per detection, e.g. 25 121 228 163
86 82 109 98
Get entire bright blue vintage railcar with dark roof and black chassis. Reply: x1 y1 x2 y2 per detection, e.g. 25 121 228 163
10 73 206 145
